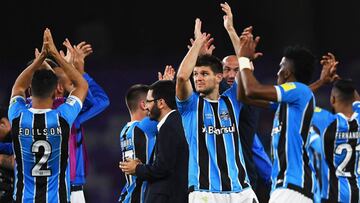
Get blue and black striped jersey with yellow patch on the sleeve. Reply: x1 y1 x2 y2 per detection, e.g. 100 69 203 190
272 82 315 199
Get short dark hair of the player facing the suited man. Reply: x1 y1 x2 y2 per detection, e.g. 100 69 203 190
125 84 149 112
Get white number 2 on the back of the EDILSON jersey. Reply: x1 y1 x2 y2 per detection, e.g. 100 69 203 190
31 140 51 176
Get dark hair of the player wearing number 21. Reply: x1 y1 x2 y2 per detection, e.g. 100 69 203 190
333 79 355 103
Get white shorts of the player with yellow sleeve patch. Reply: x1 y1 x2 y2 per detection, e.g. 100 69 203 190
269 188 313 203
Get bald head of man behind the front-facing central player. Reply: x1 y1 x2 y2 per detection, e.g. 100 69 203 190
222 55 239 85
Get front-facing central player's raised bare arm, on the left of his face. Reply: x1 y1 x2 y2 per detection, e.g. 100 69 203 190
176 18 206 100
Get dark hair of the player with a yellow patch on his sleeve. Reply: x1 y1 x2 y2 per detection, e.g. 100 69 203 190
284 45 315 84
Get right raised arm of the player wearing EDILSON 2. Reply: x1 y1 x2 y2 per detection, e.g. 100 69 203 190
45 28 88 102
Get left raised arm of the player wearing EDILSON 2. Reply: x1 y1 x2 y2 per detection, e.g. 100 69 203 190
11 31 48 98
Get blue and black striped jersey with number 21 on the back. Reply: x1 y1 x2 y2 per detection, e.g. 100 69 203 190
314 102 360 202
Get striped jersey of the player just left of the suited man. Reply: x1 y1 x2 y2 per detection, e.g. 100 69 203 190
119 117 158 203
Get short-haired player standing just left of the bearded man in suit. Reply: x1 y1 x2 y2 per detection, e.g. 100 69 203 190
119 84 157 203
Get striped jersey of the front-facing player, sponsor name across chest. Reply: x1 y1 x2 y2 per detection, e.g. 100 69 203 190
177 83 251 192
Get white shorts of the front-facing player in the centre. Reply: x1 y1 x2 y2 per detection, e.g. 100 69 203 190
189 188 259 203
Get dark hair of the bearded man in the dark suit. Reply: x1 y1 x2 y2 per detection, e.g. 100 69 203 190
150 80 177 109
